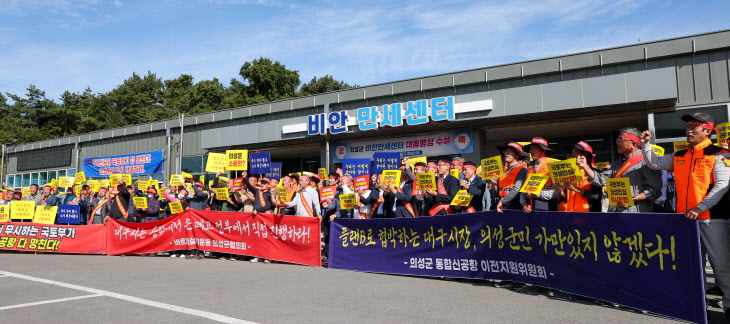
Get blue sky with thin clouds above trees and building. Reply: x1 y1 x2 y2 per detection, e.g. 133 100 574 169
0 0 730 99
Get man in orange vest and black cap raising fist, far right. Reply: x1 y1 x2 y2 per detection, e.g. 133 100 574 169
641 112 730 320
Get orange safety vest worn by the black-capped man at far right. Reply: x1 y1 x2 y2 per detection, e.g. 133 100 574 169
674 139 727 219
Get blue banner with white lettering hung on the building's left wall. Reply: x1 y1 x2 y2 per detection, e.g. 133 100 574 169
84 150 163 178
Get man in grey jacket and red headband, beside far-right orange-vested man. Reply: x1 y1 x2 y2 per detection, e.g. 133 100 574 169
577 127 662 213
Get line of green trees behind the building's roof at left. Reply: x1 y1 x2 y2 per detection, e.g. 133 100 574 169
0 57 357 143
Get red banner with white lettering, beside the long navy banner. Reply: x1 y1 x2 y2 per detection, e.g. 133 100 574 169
107 210 322 267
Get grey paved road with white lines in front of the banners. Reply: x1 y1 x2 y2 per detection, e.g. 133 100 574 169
0 253 722 324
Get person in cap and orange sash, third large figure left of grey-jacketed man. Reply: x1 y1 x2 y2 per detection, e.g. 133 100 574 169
520 137 558 213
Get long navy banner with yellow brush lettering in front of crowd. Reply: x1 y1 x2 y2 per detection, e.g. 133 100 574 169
329 210 706 323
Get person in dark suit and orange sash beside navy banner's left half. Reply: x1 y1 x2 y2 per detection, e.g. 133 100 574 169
421 160 459 216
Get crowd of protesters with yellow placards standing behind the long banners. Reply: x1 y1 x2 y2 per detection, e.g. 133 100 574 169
0 113 730 314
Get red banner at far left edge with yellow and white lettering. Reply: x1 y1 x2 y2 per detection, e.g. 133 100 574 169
0 223 106 254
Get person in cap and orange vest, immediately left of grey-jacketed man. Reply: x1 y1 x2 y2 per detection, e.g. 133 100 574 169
555 141 603 212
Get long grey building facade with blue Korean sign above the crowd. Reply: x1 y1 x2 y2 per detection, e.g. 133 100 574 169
4 30 730 188
